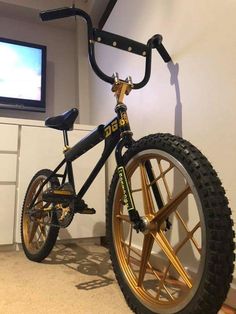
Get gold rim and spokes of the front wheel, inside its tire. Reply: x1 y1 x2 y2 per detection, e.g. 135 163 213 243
108 133 232 314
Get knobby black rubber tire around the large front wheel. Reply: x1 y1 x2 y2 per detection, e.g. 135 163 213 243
106 134 235 314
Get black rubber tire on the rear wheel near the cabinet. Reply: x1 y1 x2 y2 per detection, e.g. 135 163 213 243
21 169 60 262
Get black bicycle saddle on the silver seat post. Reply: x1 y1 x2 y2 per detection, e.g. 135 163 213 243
45 108 79 131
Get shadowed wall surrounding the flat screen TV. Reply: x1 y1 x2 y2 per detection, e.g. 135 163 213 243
0 14 77 120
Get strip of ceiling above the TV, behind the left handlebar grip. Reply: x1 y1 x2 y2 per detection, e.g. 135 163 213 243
0 0 110 30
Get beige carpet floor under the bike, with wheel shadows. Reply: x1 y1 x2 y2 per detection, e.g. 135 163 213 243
0 244 235 314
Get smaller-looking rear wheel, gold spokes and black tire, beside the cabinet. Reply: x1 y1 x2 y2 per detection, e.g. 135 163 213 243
21 169 60 262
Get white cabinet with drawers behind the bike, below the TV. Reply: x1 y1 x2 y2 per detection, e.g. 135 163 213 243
0 118 105 244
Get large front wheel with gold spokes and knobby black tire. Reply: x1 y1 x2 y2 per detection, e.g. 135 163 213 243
107 134 234 314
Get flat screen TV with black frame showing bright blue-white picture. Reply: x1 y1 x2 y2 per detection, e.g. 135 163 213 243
0 38 46 112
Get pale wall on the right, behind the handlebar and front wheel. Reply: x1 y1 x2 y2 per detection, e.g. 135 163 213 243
88 0 236 300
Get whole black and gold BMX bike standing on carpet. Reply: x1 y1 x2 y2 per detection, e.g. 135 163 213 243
21 7 234 314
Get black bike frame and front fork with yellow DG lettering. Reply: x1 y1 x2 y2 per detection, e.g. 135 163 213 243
29 99 146 231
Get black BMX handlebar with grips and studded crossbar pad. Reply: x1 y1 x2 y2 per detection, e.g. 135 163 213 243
40 7 171 89
